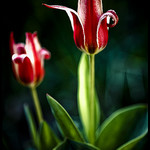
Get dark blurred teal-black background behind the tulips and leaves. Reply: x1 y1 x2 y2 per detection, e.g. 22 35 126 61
1 0 148 150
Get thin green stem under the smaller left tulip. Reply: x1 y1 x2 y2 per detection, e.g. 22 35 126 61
31 87 43 124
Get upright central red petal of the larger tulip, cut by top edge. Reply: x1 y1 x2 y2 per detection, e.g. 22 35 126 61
77 0 103 54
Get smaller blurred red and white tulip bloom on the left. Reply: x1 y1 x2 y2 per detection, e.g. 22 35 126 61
10 32 50 87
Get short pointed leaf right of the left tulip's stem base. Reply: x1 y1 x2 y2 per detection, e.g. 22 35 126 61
39 121 60 150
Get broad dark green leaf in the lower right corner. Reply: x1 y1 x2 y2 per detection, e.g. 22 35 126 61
96 104 148 150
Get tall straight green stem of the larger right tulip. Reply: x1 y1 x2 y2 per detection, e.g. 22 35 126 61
89 54 96 144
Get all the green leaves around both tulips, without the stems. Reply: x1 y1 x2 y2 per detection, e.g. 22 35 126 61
24 54 148 150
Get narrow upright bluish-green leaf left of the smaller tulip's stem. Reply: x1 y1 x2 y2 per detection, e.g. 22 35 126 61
24 104 37 146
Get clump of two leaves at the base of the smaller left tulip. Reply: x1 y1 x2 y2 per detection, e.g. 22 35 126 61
24 105 60 150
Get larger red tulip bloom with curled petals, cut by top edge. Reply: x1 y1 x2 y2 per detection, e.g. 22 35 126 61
43 0 118 54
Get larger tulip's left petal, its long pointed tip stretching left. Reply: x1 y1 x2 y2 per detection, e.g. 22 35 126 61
43 4 85 49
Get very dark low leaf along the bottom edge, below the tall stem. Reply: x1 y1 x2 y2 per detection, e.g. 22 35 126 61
53 139 100 150
